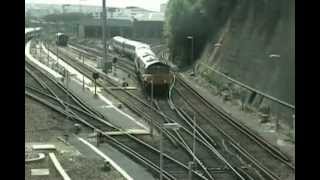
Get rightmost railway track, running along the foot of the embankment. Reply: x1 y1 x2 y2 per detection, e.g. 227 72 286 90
172 76 295 179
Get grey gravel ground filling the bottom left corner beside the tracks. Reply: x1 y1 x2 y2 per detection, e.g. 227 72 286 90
25 97 124 180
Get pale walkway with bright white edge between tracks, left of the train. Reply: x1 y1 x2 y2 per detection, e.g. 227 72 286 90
26 40 149 132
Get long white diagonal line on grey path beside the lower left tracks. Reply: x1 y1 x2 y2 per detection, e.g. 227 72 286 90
78 137 133 180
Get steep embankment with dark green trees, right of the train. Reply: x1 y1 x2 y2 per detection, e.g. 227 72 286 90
164 0 295 104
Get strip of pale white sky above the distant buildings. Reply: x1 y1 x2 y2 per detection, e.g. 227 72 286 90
25 0 169 11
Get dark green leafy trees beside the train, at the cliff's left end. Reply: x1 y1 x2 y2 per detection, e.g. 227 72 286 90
164 0 238 65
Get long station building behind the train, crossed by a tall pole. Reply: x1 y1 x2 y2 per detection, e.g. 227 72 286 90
77 7 164 38
